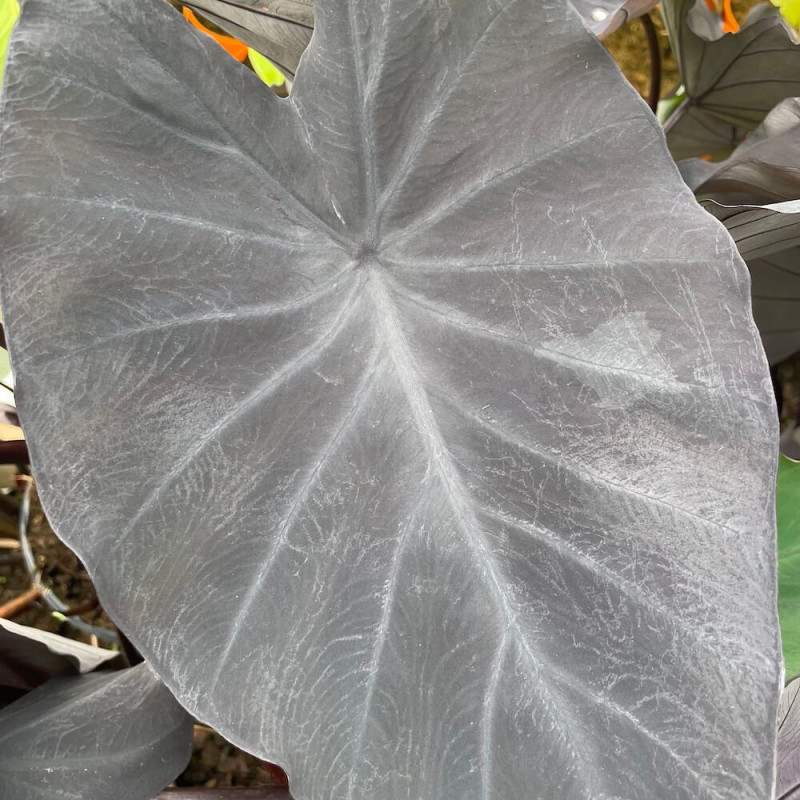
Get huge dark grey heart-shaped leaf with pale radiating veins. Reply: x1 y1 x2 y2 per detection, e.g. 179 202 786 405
0 0 780 800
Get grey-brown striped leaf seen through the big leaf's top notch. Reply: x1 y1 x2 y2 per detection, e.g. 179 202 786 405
184 0 314 78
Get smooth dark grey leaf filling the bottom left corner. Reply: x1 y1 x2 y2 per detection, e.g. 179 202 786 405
0 664 192 800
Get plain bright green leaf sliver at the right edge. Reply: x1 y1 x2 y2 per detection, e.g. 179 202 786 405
777 456 800 677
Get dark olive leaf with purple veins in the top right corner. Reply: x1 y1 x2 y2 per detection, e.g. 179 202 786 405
661 0 800 159
